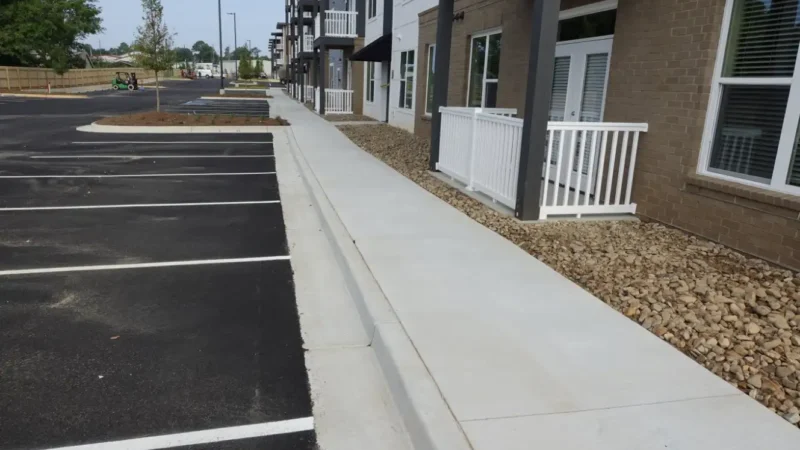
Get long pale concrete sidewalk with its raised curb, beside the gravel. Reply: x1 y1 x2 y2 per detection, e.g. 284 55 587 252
270 89 800 450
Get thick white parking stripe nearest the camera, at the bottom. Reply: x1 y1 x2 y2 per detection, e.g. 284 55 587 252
43 417 314 450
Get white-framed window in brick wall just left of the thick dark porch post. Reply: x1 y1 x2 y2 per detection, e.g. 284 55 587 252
467 32 502 108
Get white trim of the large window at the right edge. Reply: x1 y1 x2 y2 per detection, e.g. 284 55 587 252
697 0 800 195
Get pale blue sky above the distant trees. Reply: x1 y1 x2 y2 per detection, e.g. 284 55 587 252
86 0 285 55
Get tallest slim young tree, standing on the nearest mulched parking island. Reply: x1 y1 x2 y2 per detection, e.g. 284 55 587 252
133 0 175 111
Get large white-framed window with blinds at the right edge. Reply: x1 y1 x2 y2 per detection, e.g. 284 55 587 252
699 0 800 194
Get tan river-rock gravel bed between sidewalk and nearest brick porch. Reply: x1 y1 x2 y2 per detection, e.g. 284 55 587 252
339 124 800 425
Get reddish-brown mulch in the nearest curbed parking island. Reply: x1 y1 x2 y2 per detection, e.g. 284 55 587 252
97 111 289 127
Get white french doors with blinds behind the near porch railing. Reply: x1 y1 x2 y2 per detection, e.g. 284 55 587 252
548 36 614 194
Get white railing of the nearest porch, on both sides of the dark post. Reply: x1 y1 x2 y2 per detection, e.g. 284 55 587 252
437 107 648 219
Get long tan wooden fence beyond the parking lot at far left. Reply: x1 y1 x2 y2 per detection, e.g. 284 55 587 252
0 66 166 90
